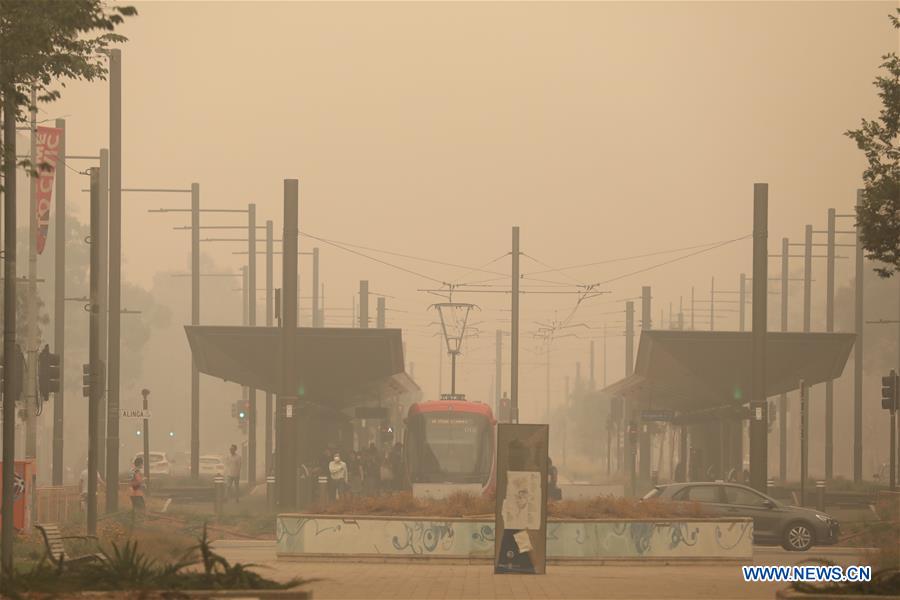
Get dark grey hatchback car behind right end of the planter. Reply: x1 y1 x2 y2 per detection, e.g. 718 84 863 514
643 481 840 552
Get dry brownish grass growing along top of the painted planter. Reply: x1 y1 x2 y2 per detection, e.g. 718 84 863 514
306 492 707 519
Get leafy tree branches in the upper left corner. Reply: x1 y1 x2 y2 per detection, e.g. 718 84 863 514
0 0 137 183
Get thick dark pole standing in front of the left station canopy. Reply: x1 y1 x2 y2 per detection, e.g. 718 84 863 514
275 179 300 510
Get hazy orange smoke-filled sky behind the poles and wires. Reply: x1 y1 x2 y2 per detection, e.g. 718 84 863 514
14 2 898 472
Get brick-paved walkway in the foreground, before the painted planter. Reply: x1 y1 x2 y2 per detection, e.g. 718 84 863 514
209 541 853 600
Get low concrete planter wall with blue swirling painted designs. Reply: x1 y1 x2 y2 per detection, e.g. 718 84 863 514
275 514 753 563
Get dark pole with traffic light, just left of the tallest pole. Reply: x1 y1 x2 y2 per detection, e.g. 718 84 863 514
87 167 105 535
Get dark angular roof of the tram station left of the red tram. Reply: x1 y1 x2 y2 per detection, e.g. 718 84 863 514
184 325 418 405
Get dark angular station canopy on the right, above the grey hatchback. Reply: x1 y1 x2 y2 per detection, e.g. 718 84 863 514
599 330 856 412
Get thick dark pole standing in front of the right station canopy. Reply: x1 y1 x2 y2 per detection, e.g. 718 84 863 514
750 183 769 493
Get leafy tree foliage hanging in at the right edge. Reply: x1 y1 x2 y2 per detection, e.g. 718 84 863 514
845 9 900 277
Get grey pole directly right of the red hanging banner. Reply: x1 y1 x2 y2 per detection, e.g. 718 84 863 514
51 119 66 486
